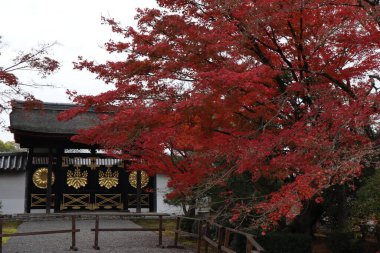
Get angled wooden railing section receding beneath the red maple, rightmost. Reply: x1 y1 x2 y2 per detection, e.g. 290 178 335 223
171 216 265 253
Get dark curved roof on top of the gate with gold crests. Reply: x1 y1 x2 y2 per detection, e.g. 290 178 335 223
10 101 99 135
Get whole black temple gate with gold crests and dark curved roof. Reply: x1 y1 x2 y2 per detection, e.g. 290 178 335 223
10 102 156 212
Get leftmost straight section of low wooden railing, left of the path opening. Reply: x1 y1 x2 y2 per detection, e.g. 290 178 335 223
0 215 80 253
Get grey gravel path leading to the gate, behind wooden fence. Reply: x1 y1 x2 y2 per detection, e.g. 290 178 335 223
3 219 192 253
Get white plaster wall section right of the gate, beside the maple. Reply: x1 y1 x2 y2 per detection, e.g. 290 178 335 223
156 174 182 214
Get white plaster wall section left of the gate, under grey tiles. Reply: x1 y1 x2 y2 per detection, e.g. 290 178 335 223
0 172 26 214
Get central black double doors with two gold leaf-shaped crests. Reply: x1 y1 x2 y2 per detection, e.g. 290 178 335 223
60 157 124 210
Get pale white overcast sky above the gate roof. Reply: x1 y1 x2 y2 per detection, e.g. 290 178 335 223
0 0 156 141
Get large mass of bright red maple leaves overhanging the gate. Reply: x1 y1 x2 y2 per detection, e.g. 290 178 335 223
62 0 380 227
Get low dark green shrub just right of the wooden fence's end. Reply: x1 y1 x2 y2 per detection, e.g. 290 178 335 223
257 232 312 253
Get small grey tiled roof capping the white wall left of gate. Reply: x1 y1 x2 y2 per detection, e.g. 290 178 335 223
0 152 28 172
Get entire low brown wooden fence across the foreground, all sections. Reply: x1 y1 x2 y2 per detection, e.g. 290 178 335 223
0 212 265 253
